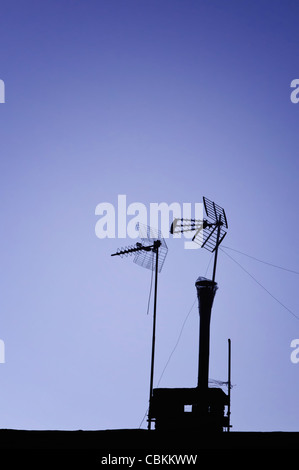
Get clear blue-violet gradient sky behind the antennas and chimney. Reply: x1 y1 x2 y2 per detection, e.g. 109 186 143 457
0 0 299 431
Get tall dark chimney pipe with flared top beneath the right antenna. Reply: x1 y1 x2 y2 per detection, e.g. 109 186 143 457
195 277 218 393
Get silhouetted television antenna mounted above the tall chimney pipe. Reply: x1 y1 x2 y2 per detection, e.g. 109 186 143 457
170 197 228 283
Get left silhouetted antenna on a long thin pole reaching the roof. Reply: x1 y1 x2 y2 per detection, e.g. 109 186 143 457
111 223 168 430
